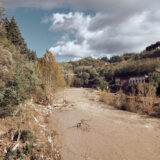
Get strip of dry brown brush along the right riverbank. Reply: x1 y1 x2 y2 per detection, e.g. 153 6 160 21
99 91 160 117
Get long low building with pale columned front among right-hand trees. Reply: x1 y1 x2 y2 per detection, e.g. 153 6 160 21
115 75 148 87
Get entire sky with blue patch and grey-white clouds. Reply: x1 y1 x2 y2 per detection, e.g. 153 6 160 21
0 0 160 60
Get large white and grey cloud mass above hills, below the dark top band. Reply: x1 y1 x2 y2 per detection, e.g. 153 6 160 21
47 12 160 57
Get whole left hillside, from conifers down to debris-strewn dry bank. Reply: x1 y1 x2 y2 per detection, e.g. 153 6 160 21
0 6 65 160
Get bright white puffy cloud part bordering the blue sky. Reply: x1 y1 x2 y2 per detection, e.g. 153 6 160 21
49 12 103 57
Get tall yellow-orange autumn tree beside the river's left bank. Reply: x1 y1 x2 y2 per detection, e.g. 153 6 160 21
37 50 65 92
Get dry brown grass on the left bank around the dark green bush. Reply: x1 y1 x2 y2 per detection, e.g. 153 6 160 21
0 100 61 160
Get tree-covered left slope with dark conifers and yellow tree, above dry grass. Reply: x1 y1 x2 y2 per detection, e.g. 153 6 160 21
0 7 65 117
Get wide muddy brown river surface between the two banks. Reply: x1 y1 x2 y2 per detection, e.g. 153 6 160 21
50 88 160 160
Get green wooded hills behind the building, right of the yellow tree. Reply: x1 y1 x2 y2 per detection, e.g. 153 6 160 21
61 42 160 95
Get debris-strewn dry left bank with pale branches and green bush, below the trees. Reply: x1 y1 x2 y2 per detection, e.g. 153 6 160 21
0 99 67 160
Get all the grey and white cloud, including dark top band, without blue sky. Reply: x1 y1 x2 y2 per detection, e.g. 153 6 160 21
0 0 160 57
